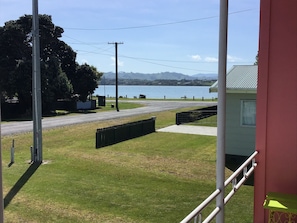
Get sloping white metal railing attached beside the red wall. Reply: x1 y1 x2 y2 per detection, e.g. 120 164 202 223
180 151 258 223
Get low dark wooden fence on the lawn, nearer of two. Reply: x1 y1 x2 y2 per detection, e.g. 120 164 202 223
96 117 156 149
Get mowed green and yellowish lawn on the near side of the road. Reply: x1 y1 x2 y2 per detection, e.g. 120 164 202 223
2 107 253 223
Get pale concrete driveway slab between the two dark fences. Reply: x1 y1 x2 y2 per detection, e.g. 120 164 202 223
157 125 217 136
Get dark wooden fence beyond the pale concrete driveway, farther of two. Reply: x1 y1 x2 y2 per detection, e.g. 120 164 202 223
175 105 217 125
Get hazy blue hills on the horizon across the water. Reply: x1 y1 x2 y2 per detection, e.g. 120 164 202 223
101 72 218 81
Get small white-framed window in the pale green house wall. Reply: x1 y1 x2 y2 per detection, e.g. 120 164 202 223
241 100 256 126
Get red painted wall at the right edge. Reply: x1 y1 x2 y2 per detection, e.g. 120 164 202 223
254 0 297 223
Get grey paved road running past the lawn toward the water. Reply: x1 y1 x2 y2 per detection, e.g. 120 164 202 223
1 100 216 135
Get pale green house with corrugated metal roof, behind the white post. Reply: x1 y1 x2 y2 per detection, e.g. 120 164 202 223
209 65 258 169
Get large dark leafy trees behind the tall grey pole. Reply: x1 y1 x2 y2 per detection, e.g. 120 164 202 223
0 15 103 115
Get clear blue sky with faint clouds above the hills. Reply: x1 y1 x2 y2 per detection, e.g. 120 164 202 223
0 0 260 75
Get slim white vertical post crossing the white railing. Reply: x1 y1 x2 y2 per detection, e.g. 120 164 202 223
216 0 228 223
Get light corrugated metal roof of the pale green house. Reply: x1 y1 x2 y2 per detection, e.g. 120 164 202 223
209 65 258 93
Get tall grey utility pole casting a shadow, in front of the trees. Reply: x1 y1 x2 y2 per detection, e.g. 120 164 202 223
32 0 42 163
